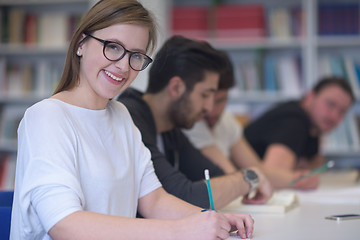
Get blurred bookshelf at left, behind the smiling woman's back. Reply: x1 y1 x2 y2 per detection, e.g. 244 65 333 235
0 0 95 190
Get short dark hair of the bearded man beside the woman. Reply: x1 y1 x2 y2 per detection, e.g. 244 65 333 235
146 36 225 93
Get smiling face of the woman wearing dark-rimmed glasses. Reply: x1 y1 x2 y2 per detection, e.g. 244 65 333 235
79 24 149 102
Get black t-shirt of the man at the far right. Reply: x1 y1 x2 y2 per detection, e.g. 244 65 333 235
244 101 319 160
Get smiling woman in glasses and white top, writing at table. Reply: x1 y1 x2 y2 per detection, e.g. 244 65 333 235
10 0 253 240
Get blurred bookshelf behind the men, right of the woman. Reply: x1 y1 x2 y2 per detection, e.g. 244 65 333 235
169 0 360 167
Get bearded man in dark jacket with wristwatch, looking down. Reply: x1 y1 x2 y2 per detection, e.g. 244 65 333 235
118 36 272 208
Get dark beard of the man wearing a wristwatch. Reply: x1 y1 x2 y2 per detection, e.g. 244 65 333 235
168 93 196 129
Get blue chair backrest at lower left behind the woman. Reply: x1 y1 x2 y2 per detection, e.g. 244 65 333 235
0 191 14 239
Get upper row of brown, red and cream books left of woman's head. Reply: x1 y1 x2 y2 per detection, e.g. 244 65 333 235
0 7 81 47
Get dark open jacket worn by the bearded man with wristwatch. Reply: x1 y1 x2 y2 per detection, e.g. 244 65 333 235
118 88 224 208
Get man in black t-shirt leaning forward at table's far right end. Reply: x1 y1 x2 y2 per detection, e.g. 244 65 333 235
244 76 354 189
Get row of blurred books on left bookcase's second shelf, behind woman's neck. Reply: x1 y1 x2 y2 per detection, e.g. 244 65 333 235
0 58 63 97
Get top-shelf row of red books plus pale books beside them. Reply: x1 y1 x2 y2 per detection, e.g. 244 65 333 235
171 4 302 38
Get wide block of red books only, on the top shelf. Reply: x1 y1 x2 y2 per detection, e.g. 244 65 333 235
172 4 266 39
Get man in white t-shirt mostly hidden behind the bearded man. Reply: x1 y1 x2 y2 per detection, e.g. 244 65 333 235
183 52 332 189
